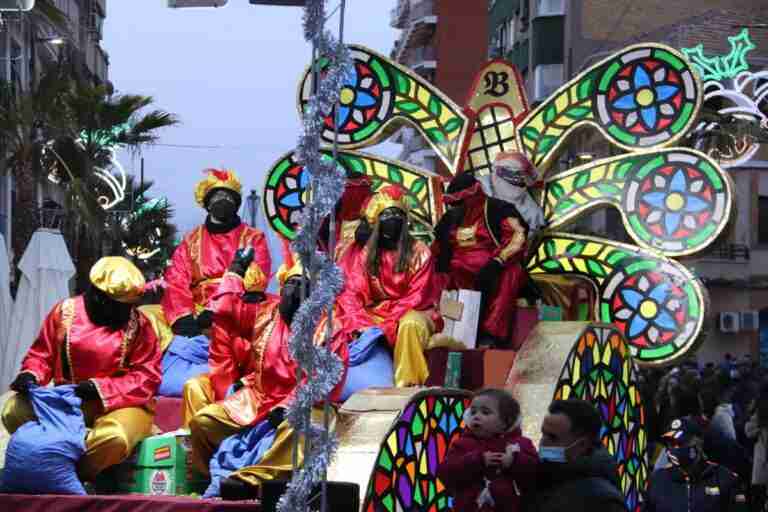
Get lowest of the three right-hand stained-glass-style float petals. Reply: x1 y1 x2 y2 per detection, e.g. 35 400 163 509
527 233 708 366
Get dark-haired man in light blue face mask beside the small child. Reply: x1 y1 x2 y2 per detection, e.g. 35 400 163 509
523 400 627 512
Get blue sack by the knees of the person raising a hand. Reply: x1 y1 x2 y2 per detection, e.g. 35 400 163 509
203 420 277 498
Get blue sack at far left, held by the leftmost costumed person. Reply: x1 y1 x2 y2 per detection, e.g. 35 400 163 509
2 385 86 494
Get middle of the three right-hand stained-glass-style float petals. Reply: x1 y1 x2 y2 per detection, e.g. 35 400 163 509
544 148 733 256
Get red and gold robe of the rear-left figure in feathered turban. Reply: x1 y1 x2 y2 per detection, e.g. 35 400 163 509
162 224 272 325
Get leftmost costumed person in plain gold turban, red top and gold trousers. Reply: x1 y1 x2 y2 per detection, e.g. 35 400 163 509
2 256 161 481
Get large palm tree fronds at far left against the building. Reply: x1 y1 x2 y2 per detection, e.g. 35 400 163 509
0 55 178 276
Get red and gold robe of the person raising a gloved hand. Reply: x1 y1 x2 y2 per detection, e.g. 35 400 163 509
209 273 365 427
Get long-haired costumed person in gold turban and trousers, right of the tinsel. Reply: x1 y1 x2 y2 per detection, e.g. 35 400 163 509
352 185 442 387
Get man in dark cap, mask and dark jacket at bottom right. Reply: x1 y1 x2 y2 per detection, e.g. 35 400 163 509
645 418 748 512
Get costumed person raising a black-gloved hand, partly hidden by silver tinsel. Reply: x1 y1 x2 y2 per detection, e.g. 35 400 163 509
184 251 364 486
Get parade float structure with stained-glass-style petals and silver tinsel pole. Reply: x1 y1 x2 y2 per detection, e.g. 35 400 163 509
0 2 744 512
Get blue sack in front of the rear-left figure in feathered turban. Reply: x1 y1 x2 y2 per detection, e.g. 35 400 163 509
157 335 208 396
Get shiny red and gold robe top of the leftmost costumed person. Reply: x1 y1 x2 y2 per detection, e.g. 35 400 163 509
21 295 162 412
